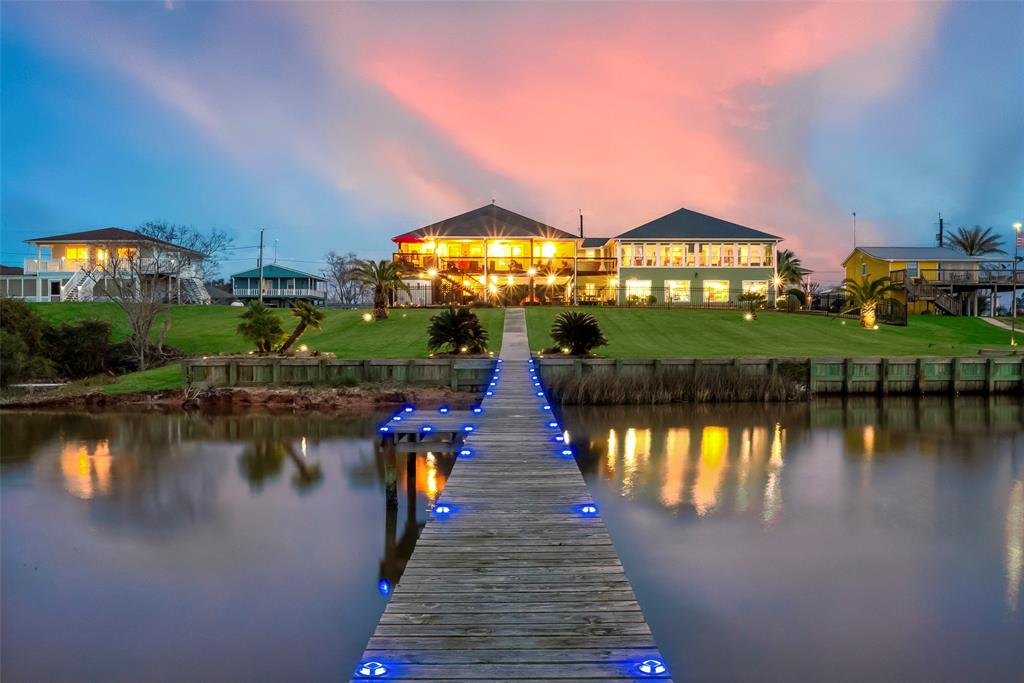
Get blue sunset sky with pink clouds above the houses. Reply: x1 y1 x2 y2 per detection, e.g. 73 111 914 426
0 0 1024 281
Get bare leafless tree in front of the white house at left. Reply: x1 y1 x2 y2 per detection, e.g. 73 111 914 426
84 239 203 370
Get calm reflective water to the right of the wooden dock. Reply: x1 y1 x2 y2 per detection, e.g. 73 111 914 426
563 399 1024 683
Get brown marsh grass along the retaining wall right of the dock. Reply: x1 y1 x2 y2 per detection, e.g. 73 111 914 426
545 366 807 405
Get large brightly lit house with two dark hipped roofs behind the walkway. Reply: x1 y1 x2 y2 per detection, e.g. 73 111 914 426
392 204 781 305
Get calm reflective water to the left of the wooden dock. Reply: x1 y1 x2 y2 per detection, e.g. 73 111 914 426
0 414 452 682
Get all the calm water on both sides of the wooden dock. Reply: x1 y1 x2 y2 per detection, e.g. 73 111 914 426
0 399 1024 683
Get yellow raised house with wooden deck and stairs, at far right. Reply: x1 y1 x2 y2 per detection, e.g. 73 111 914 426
843 247 1012 315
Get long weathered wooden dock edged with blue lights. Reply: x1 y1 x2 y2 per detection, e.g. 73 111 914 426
353 308 669 681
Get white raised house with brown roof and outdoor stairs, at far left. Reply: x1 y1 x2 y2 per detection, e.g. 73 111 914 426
0 227 210 303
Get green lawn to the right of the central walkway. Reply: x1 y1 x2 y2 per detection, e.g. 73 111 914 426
526 307 1010 358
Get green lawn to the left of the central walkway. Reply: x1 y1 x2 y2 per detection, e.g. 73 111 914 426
32 302 505 393
